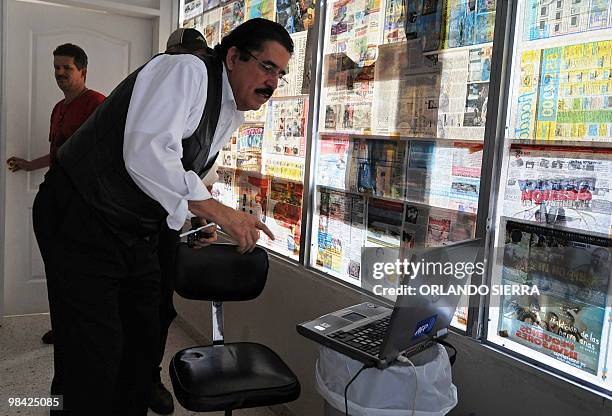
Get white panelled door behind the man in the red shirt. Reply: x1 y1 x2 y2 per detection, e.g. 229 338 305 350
0 0 153 319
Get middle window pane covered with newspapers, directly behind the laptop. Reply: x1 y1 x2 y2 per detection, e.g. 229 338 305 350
311 0 495 329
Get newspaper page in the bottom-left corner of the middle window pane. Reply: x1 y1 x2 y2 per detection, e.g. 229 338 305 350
315 187 365 285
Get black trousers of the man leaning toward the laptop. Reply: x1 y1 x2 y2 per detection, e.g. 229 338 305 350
33 167 160 415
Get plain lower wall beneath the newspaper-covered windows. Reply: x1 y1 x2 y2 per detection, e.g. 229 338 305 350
175 257 612 416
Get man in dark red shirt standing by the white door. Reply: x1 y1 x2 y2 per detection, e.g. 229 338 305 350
6 43 105 344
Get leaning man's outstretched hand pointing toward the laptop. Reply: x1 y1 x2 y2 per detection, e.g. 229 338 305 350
189 199 274 254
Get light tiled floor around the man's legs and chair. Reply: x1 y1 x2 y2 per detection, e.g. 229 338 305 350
0 315 273 416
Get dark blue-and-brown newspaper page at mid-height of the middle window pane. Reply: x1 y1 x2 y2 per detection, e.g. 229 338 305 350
348 139 408 200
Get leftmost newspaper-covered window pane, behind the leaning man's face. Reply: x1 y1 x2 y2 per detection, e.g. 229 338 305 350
181 0 315 260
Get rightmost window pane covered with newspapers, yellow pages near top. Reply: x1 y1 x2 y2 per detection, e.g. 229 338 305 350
488 0 612 392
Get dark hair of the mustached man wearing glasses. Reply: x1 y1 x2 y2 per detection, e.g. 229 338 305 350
215 17 293 62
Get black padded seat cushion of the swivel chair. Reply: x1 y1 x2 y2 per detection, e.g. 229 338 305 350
170 342 300 412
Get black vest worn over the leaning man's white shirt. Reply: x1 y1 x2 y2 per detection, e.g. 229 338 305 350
57 55 223 245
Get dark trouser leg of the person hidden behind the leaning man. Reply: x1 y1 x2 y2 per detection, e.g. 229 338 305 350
153 223 180 381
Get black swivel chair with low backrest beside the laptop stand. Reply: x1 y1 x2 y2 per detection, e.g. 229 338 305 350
170 244 300 416
